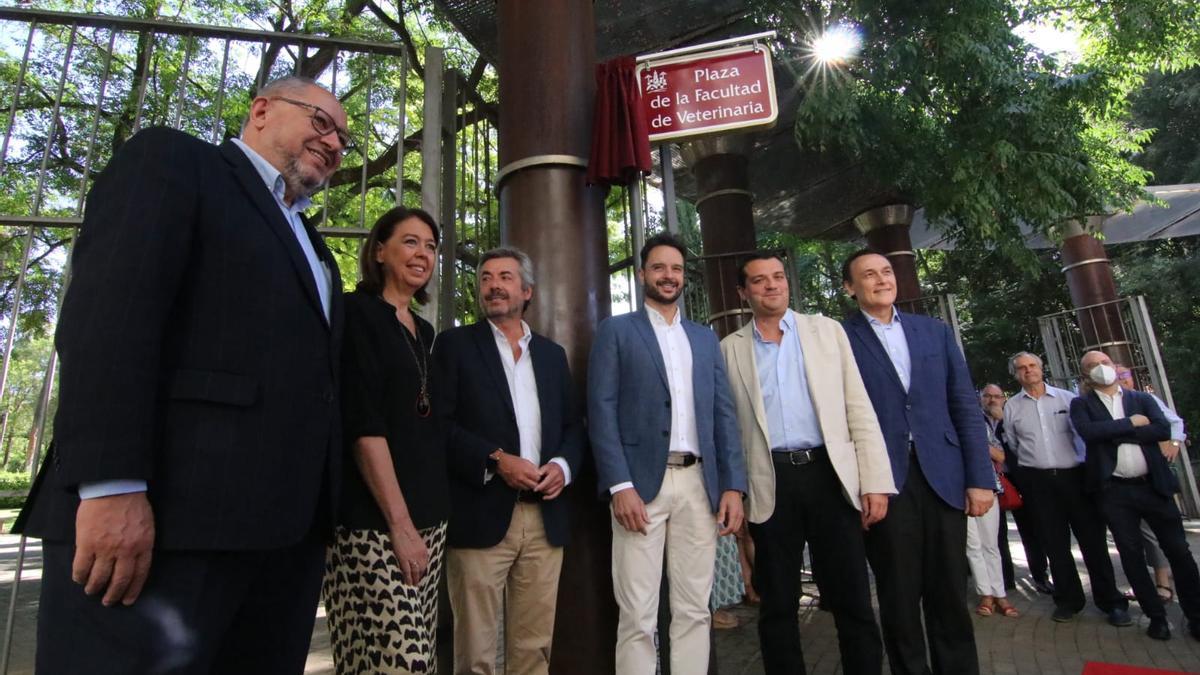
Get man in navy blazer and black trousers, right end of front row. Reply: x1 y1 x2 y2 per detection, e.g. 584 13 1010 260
842 250 996 675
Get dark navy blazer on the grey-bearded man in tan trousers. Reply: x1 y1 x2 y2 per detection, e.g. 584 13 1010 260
433 321 584 549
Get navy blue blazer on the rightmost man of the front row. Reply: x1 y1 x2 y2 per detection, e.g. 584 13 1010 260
842 311 996 509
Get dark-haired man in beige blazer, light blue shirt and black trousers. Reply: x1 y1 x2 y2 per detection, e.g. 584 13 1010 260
721 253 896 675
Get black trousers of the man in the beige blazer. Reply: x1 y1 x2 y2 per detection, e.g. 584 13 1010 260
750 452 883 675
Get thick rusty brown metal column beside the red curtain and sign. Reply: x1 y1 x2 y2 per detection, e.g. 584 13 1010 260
497 0 617 675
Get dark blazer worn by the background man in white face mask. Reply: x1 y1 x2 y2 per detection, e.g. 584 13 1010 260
1070 389 1180 497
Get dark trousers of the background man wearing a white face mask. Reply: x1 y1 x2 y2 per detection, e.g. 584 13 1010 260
1099 482 1200 622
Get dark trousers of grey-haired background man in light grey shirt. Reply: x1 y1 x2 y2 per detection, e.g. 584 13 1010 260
1021 466 1129 613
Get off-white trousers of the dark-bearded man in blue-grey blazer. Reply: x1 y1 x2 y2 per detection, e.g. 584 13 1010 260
612 464 716 675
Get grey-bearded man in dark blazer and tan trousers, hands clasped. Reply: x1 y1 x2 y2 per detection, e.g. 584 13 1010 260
433 247 584 675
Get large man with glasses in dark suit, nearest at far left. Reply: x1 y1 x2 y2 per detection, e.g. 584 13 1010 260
19 77 349 674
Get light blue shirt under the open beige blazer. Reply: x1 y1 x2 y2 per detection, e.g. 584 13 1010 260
754 312 824 450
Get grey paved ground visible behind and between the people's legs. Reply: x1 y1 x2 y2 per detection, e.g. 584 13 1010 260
0 514 1200 675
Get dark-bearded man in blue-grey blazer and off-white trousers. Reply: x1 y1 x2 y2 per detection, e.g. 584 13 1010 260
588 234 746 674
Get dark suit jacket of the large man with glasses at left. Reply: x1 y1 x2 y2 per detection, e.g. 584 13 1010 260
15 127 342 550
